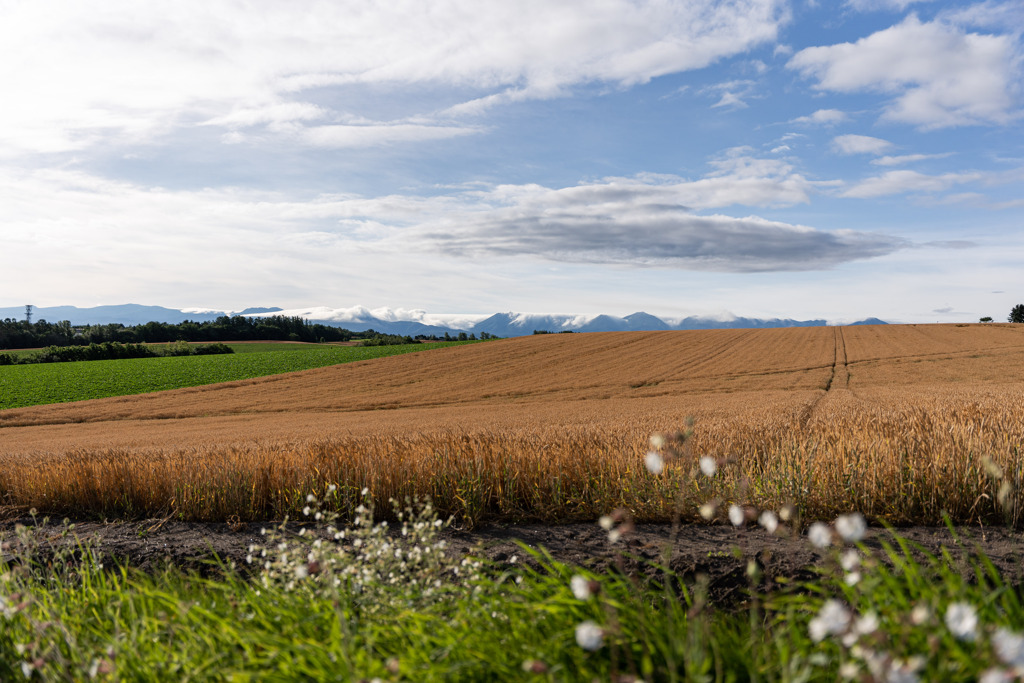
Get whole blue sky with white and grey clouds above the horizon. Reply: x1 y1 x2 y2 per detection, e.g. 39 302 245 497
0 0 1024 323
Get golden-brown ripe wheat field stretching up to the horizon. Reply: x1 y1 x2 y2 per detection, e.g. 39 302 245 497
0 325 1024 524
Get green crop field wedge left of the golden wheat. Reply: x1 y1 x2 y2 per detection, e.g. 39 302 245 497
0 342 472 410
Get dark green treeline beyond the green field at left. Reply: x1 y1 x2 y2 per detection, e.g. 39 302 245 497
0 315 497 349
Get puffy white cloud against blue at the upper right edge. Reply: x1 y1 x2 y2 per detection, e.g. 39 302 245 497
787 15 1020 128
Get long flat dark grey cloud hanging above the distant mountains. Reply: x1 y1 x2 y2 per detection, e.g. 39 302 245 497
423 210 909 272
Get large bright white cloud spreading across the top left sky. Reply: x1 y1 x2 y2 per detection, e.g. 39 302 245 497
0 0 786 156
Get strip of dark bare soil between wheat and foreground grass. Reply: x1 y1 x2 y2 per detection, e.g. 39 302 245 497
0 517 1024 602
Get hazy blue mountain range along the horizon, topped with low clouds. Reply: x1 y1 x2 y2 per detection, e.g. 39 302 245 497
0 304 886 337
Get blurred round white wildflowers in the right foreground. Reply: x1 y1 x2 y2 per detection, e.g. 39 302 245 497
630 425 1024 683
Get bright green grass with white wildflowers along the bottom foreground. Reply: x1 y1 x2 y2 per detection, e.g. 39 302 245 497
6 493 1024 683
